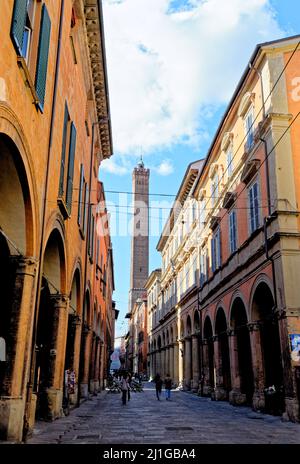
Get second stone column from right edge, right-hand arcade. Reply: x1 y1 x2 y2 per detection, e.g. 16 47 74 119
248 323 265 411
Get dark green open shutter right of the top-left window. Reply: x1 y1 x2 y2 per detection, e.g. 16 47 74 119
35 5 51 108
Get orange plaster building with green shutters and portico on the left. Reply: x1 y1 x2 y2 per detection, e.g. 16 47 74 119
0 0 114 441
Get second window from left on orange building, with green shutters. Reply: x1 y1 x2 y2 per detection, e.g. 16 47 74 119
58 105 76 216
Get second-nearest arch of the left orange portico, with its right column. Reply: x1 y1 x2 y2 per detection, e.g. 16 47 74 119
34 227 69 420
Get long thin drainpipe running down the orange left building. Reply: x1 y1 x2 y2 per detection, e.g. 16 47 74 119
23 0 64 441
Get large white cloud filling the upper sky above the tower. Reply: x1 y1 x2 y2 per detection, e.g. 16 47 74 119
103 0 284 156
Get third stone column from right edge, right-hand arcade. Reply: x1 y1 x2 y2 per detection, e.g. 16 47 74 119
227 330 246 405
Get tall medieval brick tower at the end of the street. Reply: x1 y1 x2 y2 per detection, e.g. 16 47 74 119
129 159 150 312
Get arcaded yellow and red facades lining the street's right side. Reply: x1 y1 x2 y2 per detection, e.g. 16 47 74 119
149 36 300 421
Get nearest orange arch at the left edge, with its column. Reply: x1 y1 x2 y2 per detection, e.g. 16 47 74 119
0 132 37 441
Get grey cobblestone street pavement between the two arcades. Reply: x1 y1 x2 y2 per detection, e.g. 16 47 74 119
28 383 300 444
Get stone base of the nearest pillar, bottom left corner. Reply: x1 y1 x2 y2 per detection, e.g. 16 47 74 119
0 397 25 442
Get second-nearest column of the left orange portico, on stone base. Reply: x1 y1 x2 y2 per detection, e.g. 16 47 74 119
47 294 69 420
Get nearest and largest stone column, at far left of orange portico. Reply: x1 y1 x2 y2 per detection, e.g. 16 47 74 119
0 256 37 441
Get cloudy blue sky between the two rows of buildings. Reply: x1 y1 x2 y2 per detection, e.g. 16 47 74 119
100 0 300 335
